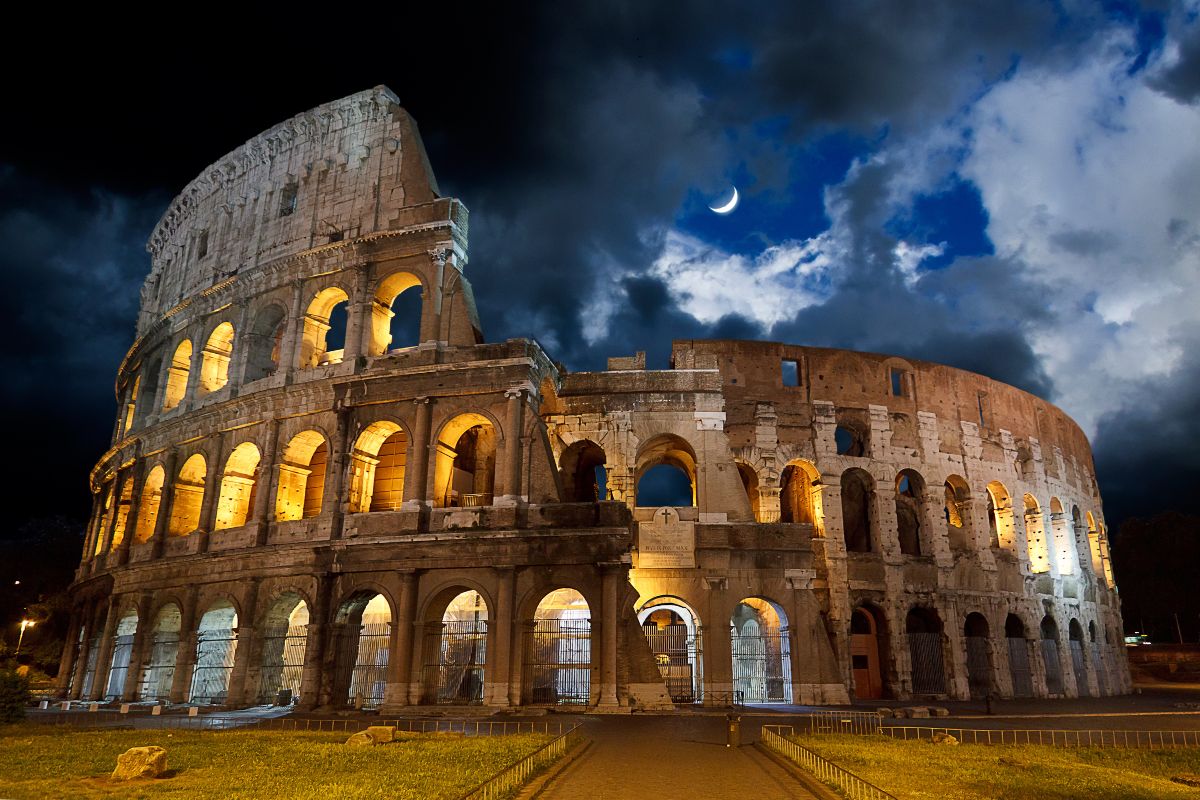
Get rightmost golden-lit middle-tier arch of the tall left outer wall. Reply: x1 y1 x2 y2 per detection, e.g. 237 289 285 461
433 413 497 507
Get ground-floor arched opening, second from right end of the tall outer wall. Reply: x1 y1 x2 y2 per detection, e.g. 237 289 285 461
424 589 487 705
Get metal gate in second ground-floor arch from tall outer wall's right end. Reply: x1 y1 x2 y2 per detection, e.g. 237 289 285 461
424 620 487 705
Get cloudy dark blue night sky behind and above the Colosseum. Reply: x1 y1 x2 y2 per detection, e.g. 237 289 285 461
0 0 1200 544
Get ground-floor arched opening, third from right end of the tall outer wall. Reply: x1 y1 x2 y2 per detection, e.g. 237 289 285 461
337 593 391 709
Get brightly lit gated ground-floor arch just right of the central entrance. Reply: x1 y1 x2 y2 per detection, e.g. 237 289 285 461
730 597 792 703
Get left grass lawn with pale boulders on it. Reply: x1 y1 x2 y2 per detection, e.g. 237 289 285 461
0 724 551 800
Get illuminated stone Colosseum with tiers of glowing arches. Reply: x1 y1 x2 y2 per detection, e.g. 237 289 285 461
59 86 1129 712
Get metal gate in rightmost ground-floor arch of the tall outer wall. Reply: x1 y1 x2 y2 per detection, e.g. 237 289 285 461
524 619 592 704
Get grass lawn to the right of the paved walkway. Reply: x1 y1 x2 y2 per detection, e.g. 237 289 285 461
796 735 1200 800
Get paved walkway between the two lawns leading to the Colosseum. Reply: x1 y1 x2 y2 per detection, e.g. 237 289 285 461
539 717 815 800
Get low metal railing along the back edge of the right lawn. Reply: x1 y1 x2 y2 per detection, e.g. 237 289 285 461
878 726 1200 750
